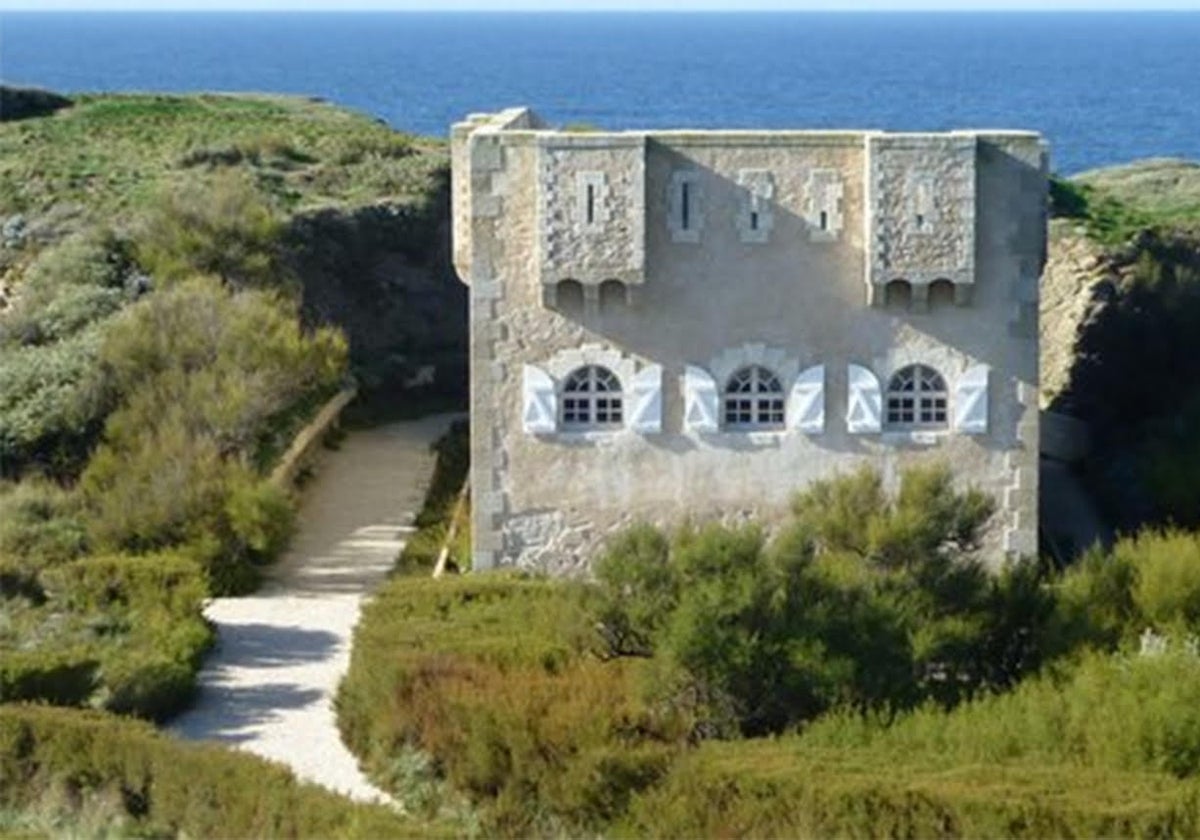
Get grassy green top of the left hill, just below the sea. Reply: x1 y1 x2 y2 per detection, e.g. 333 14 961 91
0 94 445 220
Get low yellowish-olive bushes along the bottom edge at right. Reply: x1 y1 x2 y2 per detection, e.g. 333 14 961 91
611 738 1200 839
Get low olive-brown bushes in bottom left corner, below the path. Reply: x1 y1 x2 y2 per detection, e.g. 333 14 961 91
0 706 451 838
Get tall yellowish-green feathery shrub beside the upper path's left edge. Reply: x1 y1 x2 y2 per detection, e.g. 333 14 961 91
80 280 346 593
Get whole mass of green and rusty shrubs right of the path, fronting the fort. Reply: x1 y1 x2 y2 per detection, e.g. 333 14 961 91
337 469 1200 836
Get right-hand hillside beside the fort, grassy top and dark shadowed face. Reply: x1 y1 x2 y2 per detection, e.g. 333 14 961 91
1051 161 1200 532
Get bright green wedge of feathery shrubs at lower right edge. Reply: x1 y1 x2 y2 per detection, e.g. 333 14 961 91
802 646 1200 778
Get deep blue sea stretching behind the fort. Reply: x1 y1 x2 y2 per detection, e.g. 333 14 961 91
0 13 1200 173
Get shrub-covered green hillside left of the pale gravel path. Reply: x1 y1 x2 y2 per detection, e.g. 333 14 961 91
0 95 444 719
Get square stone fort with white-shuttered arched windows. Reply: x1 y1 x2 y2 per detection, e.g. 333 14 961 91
451 109 1046 572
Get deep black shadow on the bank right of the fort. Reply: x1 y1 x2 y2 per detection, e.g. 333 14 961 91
1050 230 1200 532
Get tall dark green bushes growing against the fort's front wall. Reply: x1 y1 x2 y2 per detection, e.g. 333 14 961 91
596 468 1052 734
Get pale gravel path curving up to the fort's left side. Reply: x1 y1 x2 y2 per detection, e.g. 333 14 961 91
170 415 452 800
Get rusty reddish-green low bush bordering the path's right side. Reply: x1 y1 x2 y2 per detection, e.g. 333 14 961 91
337 575 691 835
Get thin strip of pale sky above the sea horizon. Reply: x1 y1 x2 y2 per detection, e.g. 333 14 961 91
0 0 1200 12
